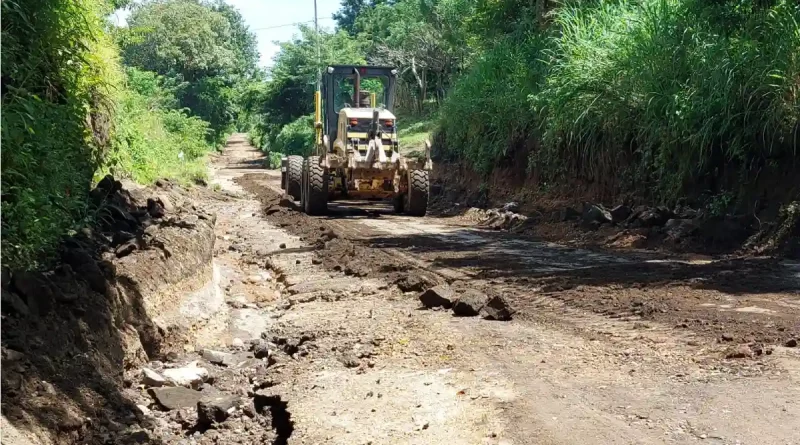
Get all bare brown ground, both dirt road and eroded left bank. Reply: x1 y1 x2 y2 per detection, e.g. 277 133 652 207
2 135 800 445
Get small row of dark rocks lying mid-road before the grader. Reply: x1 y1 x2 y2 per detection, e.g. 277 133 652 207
419 284 514 321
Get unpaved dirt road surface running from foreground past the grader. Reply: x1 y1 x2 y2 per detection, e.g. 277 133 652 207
208 135 800 445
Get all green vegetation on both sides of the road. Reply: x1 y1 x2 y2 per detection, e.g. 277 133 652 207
2 0 800 267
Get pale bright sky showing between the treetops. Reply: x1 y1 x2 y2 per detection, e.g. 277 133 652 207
115 0 341 67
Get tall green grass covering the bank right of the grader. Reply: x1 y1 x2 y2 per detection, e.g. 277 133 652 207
440 0 800 200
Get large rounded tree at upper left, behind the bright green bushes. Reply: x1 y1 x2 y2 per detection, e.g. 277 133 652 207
120 0 258 143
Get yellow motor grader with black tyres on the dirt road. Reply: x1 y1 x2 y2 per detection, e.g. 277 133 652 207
281 65 432 216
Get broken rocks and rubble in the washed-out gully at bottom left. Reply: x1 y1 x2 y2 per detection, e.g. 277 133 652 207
109 333 302 444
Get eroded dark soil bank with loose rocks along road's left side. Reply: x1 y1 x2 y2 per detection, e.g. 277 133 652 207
2 176 214 444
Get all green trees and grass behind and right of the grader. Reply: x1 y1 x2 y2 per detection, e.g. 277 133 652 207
255 0 800 207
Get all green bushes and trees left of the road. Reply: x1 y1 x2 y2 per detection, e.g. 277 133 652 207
2 0 258 269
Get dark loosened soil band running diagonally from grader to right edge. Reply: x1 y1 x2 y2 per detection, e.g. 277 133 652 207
234 174 800 349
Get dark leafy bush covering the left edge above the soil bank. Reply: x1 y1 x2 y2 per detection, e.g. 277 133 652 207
1 0 120 269
